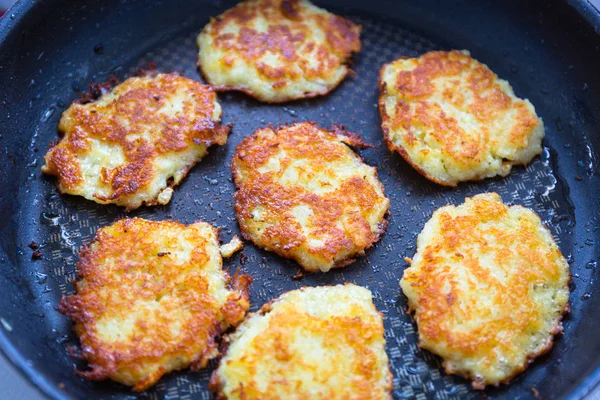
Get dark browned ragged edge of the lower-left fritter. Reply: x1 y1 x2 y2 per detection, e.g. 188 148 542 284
58 217 252 392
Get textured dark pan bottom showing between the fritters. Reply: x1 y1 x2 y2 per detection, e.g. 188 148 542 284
30 15 574 399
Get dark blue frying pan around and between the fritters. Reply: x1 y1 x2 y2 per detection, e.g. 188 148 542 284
0 0 600 400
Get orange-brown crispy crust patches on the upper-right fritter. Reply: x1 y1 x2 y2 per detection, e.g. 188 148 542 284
378 50 540 187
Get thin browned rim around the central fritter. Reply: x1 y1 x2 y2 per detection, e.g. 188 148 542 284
230 121 392 273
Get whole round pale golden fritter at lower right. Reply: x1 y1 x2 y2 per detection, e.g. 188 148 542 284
400 193 570 389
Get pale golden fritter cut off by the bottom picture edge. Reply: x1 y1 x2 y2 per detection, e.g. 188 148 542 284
211 284 392 400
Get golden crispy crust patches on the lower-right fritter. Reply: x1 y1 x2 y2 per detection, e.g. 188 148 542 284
402 194 571 390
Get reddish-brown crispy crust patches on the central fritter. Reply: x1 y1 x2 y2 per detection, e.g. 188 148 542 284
231 122 389 271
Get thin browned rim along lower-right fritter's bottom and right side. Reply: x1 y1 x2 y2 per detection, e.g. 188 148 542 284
405 208 573 390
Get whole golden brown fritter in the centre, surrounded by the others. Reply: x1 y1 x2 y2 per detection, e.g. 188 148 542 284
231 122 390 272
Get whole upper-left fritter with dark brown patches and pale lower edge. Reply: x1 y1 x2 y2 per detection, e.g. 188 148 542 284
42 74 229 210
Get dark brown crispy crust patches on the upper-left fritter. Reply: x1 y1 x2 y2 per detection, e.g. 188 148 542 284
43 74 230 211
